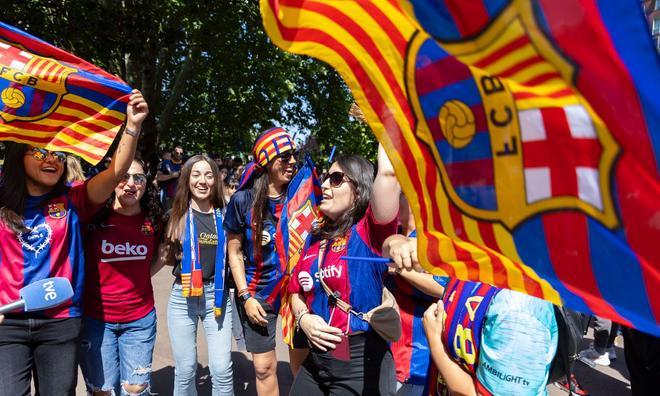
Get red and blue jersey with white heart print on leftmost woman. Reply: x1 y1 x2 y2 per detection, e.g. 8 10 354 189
0 183 99 318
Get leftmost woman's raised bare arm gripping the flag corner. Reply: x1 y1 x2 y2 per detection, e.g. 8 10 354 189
87 89 149 204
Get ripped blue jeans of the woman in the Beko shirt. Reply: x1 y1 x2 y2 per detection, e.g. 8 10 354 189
79 310 156 395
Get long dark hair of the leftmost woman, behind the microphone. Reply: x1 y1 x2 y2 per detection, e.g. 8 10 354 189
0 142 67 234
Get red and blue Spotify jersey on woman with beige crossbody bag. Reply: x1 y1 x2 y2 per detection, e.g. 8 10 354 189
289 208 397 333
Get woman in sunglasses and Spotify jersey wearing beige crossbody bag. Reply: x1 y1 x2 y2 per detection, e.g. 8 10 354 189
289 147 401 396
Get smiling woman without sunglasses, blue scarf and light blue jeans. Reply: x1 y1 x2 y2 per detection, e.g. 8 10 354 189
161 155 234 396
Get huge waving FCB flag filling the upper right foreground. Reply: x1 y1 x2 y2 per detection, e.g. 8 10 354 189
261 0 660 335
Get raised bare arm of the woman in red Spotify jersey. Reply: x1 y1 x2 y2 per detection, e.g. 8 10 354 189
371 145 401 224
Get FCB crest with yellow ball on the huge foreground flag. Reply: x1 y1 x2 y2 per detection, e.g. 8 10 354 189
406 6 618 229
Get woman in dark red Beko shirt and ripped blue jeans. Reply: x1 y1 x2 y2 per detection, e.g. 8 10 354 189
80 159 163 396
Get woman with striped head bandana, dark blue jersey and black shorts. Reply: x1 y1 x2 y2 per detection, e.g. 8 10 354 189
225 128 301 396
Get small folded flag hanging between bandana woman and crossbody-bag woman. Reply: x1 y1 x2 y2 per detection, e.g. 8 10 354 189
275 156 321 347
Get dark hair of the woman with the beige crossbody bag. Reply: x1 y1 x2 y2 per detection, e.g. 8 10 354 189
314 155 374 240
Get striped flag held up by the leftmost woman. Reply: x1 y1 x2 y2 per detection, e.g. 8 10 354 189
0 22 131 164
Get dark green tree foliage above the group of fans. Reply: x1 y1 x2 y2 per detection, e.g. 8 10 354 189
3 0 376 160
